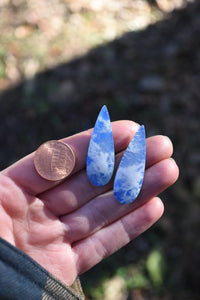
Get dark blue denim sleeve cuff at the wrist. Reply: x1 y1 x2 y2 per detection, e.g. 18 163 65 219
0 238 85 300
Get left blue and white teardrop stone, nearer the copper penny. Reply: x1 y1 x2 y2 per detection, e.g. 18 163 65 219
86 105 115 186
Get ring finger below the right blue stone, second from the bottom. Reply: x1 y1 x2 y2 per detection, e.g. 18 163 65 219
60 159 178 243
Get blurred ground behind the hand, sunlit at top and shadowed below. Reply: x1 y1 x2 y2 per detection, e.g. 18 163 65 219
0 0 200 300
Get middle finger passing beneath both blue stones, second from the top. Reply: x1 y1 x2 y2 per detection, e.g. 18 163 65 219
40 136 173 216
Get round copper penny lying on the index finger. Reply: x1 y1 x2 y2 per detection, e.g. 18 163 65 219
34 140 75 181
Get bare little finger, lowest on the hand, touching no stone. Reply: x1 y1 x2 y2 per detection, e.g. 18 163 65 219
73 198 164 274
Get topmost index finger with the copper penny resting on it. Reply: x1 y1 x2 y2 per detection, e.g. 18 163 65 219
3 121 139 194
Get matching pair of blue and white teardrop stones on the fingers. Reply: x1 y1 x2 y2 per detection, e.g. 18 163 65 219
87 105 146 204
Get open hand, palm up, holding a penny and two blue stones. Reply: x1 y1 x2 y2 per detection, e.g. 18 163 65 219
0 121 179 285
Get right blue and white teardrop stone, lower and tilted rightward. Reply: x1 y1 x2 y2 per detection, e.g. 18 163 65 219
114 125 146 204
